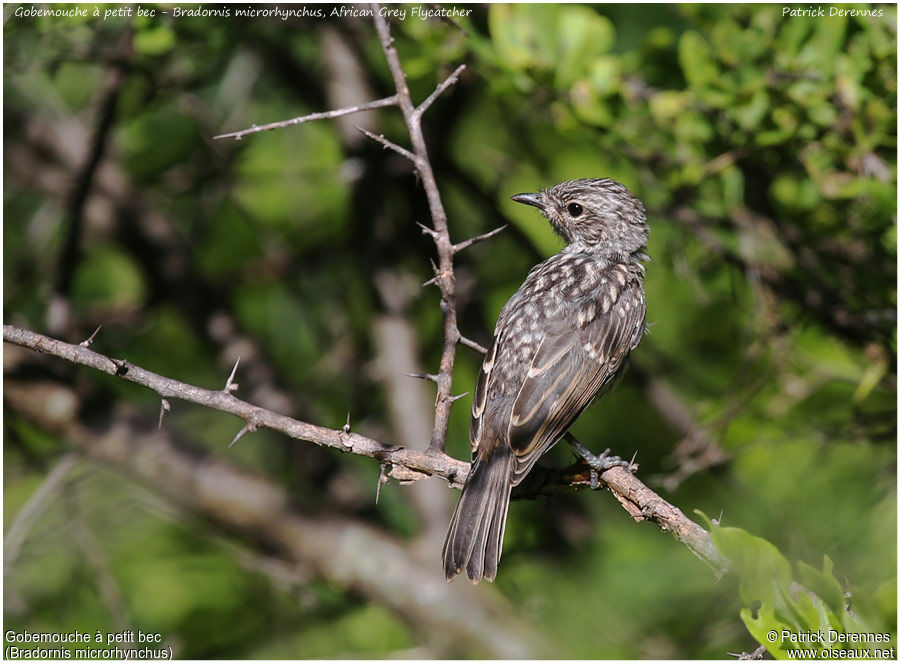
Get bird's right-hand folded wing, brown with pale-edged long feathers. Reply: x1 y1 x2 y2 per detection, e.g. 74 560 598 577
509 283 645 485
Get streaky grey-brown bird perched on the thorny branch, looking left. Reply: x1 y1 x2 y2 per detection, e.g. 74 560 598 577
442 178 650 584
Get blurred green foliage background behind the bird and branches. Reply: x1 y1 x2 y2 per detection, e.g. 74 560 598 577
3 4 897 658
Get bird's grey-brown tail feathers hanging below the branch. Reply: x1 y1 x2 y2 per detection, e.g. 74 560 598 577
443 449 515 584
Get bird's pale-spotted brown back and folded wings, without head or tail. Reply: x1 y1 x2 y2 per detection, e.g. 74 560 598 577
471 250 645 476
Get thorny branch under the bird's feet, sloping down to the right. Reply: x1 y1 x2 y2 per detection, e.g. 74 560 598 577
3 325 728 573
